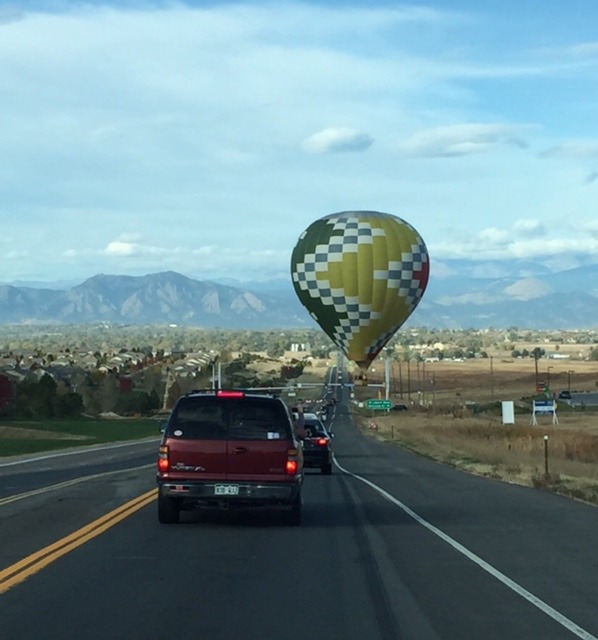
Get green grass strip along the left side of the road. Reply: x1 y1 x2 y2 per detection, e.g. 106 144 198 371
0 418 159 460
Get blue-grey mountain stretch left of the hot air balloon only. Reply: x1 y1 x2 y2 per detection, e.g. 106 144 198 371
0 271 313 329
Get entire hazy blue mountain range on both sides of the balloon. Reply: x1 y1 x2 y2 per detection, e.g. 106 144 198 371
0 260 598 329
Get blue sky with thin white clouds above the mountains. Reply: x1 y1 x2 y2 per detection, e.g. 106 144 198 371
0 0 598 282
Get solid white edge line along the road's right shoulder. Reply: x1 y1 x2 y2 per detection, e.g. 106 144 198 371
334 458 598 640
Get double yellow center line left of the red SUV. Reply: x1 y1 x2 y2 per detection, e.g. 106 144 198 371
0 489 158 594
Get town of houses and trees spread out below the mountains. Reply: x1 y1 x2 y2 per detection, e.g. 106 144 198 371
0 323 598 419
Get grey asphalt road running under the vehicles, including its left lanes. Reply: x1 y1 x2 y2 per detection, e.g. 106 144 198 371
0 398 598 640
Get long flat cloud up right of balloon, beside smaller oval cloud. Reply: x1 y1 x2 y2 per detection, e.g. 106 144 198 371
399 123 527 158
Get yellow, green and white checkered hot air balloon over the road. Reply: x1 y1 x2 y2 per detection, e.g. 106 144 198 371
291 211 430 371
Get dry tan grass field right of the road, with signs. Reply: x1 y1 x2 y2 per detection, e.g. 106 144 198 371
302 357 598 504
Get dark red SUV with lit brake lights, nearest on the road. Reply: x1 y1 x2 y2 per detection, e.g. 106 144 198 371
157 391 303 524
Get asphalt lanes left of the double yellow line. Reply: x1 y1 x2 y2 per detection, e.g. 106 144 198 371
0 439 158 576
